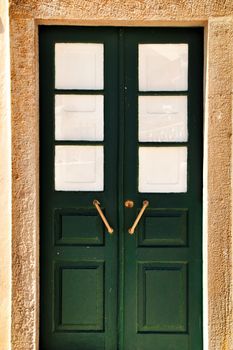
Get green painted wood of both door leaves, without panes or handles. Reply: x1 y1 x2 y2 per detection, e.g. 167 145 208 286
40 26 203 350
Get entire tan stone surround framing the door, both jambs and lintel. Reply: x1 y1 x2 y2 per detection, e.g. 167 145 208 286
4 0 233 350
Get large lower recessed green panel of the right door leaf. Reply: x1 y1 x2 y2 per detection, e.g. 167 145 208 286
137 261 188 333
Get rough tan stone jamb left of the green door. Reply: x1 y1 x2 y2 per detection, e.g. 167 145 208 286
11 19 39 350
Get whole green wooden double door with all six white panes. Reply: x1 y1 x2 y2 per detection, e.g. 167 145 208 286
40 26 203 350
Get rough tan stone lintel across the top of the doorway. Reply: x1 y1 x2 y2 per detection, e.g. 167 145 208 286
8 0 233 21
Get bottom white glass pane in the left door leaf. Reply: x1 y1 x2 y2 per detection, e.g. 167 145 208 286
55 146 104 191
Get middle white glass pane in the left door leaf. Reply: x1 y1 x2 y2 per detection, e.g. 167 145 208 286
55 95 104 141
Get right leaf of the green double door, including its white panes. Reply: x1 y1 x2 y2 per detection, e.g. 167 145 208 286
124 28 203 350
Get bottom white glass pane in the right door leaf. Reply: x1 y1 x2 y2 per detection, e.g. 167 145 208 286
139 147 187 193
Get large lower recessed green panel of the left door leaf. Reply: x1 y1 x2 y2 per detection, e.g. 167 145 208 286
54 260 104 332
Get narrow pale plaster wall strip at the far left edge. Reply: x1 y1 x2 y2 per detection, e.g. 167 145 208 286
0 0 11 350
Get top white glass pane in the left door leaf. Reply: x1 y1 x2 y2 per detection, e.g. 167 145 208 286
55 43 104 90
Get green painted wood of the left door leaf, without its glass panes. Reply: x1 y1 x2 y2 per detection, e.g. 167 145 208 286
40 26 119 350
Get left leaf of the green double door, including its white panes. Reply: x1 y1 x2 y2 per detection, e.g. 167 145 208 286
40 26 118 350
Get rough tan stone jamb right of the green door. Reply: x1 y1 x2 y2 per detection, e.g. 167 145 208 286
208 18 233 350
